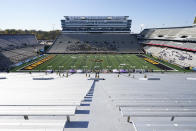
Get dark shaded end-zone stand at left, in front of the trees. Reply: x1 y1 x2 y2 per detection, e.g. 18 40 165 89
0 34 44 70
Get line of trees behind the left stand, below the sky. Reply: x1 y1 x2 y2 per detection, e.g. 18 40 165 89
0 29 61 40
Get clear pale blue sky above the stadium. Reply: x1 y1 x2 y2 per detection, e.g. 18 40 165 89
0 0 196 32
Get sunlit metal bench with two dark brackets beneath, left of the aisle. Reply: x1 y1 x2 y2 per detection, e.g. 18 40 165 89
0 106 76 122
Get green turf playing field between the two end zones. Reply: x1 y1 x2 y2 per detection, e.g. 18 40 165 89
16 54 172 71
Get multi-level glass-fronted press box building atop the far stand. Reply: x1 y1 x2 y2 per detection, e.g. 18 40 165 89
61 16 132 32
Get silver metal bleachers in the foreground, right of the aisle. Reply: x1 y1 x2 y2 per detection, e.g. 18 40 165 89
99 73 196 131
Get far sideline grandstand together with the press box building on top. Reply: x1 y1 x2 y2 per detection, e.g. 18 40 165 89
47 16 142 54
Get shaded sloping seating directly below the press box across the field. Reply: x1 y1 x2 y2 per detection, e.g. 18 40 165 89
48 33 141 53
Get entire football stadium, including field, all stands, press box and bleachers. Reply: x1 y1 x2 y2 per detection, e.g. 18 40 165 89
0 13 196 131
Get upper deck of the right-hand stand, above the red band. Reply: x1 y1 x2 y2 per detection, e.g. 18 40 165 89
140 26 196 51
